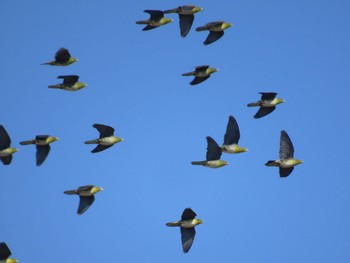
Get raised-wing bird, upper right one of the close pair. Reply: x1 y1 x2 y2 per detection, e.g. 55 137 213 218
221 115 248 153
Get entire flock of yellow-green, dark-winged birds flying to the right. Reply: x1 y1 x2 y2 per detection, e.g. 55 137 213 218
0 5 302 263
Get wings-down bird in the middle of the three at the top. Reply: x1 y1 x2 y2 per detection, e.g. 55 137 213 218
164 5 203 37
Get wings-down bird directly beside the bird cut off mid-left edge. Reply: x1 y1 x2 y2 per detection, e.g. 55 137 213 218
20 135 59 166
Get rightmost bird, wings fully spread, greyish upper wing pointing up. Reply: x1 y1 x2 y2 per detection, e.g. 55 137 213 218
265 130 303 177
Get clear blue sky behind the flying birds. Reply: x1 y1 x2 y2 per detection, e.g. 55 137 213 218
0 0 350 263
